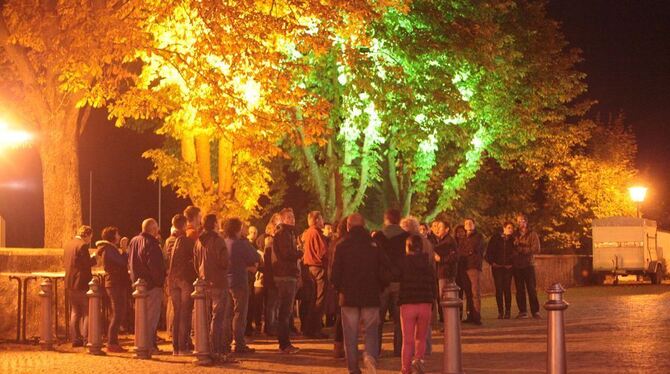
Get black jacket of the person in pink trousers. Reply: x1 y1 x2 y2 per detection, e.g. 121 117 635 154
398 253 437 305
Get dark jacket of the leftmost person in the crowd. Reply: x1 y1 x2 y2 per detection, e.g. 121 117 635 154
63 238 96 291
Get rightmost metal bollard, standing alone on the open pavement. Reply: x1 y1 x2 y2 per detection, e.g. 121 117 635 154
544 283 568 374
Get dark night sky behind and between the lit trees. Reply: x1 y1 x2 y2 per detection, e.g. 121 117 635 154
0 0 670 247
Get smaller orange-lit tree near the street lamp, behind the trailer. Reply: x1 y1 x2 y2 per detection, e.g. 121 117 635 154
448 115 637 251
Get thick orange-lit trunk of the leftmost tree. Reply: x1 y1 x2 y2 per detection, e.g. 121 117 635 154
39 107 82 248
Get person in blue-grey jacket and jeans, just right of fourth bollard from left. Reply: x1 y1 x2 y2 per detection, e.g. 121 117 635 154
223 218 260 353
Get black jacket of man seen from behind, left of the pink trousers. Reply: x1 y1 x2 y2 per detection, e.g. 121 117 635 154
332 227 384 308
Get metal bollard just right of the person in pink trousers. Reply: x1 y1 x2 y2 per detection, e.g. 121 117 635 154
440 282 464 374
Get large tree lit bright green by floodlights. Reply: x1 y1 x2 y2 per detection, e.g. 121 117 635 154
293 0 585 224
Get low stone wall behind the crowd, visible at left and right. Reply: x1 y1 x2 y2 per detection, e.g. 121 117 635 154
0 248 591 340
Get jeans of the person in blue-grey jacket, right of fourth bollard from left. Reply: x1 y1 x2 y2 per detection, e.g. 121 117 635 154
223 284 249 349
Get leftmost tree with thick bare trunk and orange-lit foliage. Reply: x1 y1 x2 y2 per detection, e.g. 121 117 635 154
0 0 150 247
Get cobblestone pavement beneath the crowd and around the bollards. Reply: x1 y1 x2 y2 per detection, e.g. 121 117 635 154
0 285 670 374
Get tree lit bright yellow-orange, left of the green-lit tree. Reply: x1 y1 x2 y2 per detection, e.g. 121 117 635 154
111 0 406 218
